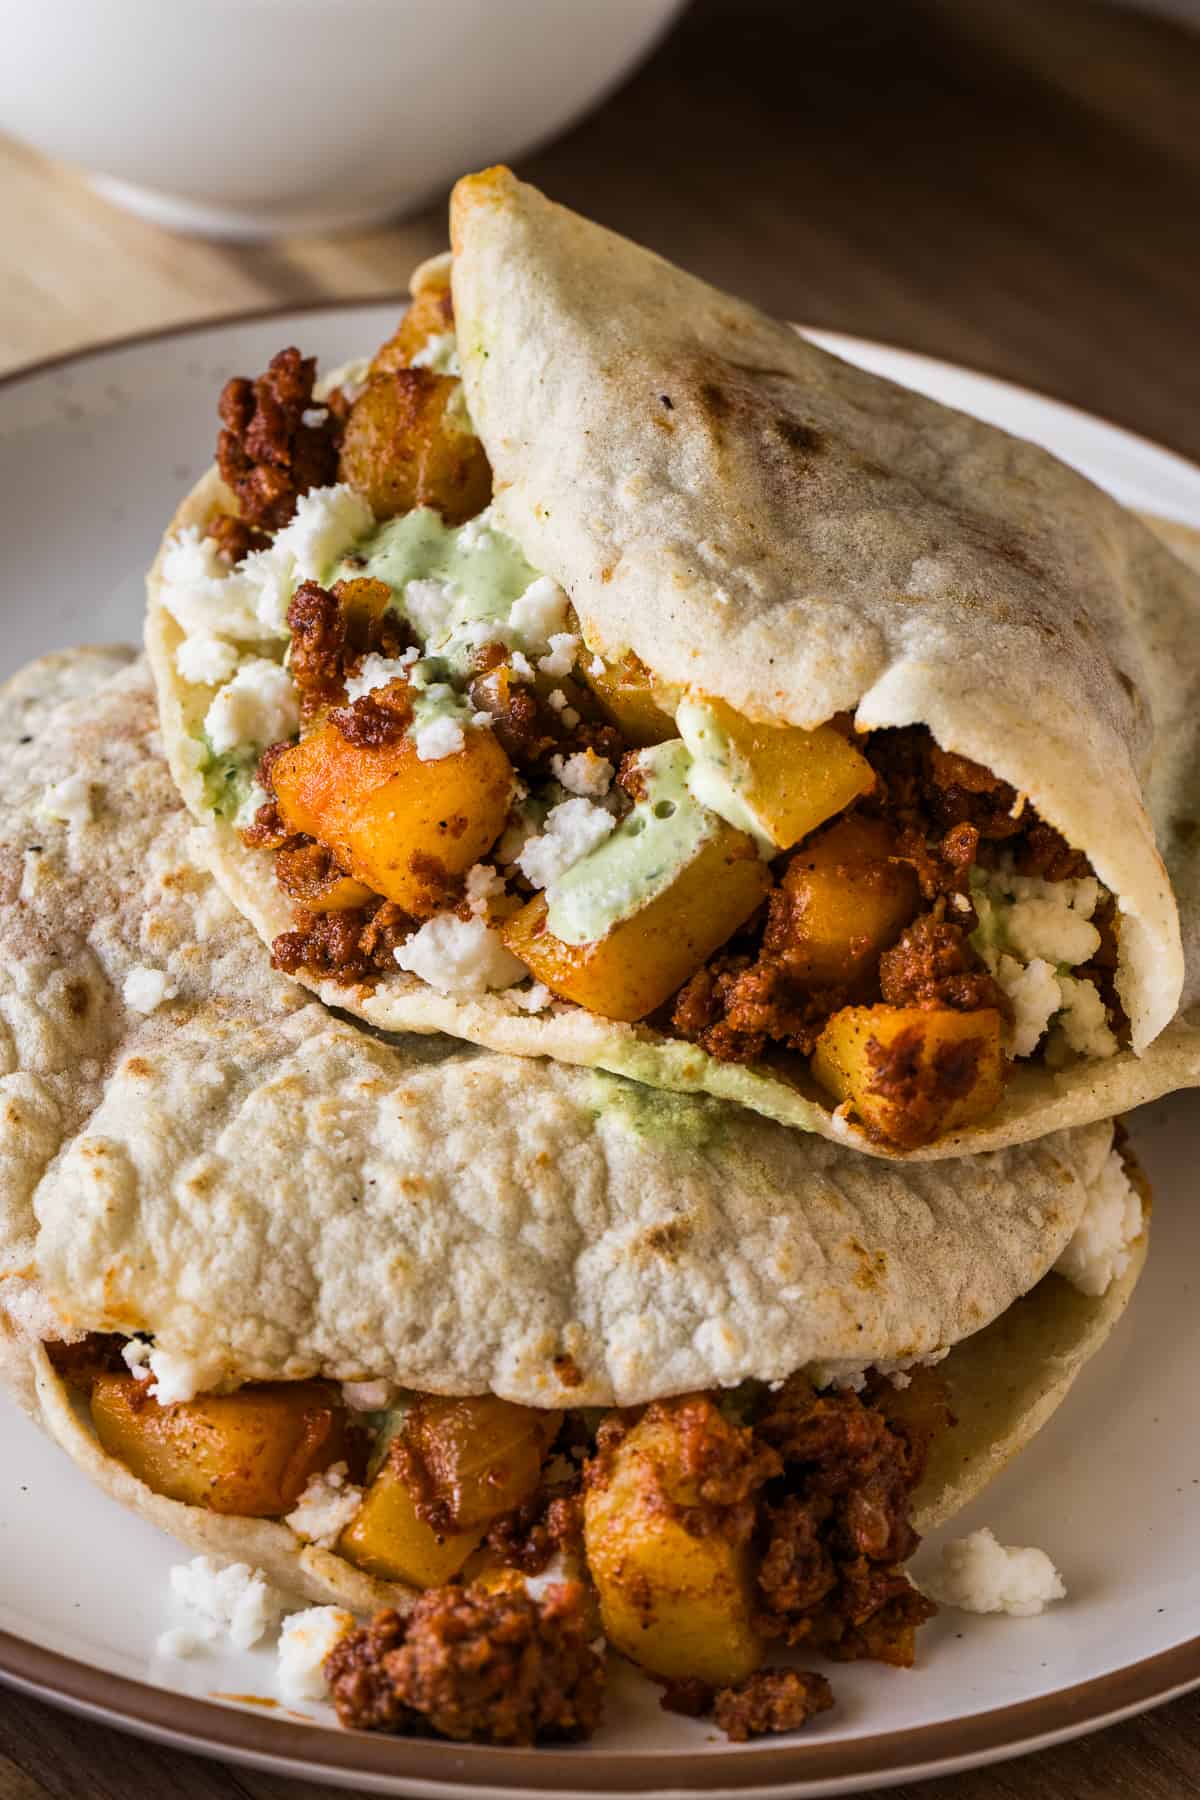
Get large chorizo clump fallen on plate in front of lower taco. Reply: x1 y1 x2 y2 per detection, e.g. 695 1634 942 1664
326 1582 604 1744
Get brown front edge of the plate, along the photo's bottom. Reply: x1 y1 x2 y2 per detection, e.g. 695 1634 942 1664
0 1631 1200 1795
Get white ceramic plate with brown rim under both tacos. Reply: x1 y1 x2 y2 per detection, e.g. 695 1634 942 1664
0 306 1200 1796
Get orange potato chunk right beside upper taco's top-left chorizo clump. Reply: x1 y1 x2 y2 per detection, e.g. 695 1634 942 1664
338 369 491 526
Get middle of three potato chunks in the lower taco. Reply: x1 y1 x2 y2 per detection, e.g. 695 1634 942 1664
338 1395 561 1588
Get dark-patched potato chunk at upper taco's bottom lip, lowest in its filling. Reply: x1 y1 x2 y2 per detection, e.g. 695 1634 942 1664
811 1006 1006 1150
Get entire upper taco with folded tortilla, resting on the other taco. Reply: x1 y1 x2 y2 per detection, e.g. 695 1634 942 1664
149 171 1195 1154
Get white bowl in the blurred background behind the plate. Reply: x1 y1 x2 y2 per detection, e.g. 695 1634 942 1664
0 0 684 238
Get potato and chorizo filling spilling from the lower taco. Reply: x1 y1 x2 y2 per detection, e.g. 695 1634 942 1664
47 1336 952 1742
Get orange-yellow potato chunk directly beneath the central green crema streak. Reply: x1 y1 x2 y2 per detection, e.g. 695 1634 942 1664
504 826 770 1019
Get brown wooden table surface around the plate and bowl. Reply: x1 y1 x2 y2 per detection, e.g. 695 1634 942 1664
0 0 1200 1800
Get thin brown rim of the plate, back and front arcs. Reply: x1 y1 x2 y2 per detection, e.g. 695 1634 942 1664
0 306 1200 1796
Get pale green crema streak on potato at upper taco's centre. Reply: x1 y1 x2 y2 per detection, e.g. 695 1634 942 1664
547 738 725 943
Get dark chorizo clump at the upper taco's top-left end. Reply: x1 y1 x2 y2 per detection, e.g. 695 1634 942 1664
216 347 338 531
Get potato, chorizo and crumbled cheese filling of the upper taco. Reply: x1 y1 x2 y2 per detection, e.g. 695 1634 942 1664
162 259 1128 1150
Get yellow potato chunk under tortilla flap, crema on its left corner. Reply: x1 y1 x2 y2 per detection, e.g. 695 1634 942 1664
678 697 874 850
